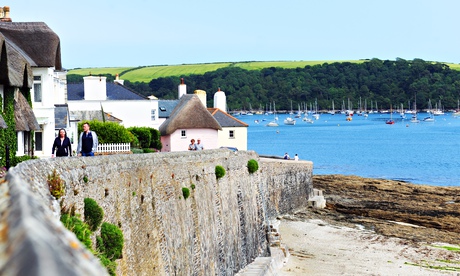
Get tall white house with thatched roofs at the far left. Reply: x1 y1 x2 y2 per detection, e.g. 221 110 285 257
0 11 66 157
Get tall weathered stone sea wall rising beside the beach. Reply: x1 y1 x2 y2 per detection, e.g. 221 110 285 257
0 150 313 275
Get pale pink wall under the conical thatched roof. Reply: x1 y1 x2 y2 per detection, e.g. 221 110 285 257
161 128 219 152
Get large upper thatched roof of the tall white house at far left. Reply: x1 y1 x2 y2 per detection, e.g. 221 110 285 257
0 22 62 88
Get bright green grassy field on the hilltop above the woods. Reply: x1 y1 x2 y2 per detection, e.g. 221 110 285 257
69 60 460 82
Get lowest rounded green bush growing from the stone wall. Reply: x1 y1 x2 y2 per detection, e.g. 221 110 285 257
98 222 124 261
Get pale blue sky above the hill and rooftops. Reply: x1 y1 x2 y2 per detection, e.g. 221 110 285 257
9 0 460 69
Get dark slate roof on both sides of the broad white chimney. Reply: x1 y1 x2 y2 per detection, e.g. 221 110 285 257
67 82 147 101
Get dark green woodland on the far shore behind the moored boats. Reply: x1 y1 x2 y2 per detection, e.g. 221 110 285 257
70 58 460 110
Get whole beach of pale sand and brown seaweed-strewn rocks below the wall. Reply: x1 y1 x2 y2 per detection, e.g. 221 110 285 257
278 175 460 275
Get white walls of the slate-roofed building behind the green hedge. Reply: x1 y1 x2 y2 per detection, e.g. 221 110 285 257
67 99 160 129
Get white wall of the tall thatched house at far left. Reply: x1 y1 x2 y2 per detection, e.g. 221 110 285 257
31 67 66 157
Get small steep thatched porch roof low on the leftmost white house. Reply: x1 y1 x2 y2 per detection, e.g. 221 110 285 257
14 89 40 131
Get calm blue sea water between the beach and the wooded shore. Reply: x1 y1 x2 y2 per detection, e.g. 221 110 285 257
238 113 460 186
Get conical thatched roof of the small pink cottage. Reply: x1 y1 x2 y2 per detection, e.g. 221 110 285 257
160 94 222 135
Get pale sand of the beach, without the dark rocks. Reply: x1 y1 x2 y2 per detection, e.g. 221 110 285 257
279 217 460 275
